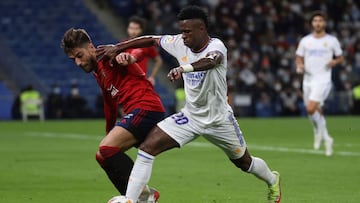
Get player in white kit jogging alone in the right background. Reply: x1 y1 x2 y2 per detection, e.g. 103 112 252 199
296 11 344 156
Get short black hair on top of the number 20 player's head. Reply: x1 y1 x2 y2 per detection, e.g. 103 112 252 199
177 5 209 28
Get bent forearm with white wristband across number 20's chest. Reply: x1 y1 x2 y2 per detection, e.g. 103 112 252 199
168 51 224 81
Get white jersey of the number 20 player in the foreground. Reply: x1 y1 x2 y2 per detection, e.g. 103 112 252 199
160 34 232 125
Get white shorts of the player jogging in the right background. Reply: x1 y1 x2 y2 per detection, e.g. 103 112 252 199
303 83 332 106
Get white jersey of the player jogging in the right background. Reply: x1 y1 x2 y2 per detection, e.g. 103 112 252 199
296 34 342 84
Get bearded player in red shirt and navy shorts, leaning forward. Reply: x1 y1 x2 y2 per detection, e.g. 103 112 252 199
61 28 165 202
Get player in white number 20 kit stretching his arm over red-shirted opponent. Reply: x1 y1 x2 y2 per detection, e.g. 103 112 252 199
98 6 281 203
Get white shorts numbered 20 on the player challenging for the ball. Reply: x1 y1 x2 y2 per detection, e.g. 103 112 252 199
157 112 246 159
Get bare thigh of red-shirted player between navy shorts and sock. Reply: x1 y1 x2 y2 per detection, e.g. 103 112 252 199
100 126 138 151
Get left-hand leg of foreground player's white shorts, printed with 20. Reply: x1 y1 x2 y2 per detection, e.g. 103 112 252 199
157 112 198 147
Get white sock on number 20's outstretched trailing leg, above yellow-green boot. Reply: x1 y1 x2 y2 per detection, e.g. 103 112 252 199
247 156 276 185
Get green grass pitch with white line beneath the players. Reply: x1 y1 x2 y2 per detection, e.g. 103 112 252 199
0 117 360 203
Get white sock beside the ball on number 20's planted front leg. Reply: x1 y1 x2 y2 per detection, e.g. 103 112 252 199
126 149 155 202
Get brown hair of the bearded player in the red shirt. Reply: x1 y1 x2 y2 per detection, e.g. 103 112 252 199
61 28 91 54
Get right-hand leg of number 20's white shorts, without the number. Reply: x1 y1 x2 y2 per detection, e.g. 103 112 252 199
203 112 246 159
